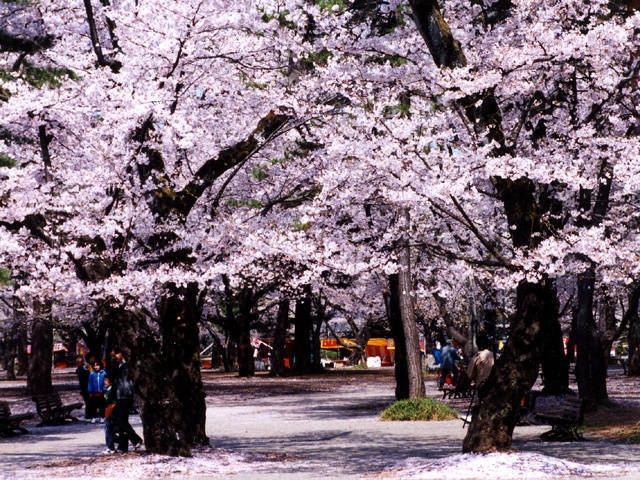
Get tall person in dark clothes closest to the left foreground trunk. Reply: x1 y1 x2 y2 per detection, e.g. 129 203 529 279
113 349 142 453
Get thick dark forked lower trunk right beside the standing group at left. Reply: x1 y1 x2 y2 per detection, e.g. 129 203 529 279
113 284 209 456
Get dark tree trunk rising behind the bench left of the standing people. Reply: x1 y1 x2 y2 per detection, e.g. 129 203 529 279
27 301 53 395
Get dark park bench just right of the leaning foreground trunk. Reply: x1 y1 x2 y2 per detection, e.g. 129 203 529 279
529 392 584 441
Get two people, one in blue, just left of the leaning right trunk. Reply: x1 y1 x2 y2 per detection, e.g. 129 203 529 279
434 340 494 388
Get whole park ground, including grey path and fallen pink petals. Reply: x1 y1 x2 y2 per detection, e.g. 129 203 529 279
0 367 640 480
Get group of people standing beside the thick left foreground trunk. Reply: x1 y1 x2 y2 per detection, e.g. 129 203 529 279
76 348 142 454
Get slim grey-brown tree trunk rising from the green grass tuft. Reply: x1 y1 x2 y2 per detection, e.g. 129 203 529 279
398 210 426 399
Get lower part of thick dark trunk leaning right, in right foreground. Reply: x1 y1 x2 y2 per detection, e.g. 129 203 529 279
462 280 558 453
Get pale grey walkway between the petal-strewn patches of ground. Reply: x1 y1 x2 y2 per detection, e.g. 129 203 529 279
0 378 640 480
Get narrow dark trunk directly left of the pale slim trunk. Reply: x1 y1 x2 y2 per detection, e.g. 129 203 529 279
385 273 409 400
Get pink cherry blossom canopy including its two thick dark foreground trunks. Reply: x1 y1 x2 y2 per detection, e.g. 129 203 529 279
0 0 640 455
